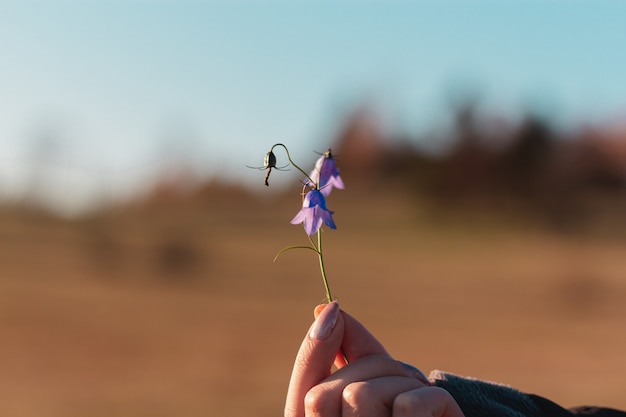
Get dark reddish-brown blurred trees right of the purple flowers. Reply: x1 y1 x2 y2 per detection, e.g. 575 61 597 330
336 103 626 231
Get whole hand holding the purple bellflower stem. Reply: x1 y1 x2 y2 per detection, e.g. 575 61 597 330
285 302 463 417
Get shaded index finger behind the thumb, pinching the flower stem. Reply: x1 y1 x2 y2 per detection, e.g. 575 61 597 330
335 310 389 368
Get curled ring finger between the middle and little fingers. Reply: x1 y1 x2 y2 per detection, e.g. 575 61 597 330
342 377 424 417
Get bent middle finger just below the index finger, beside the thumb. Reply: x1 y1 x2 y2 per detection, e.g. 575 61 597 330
305 355 425 416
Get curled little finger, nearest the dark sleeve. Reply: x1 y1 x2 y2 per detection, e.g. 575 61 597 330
392 387 465 417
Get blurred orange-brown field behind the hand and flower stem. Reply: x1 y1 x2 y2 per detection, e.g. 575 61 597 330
0 178 626 417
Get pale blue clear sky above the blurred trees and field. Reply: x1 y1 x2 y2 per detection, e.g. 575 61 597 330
0 0 626 212
